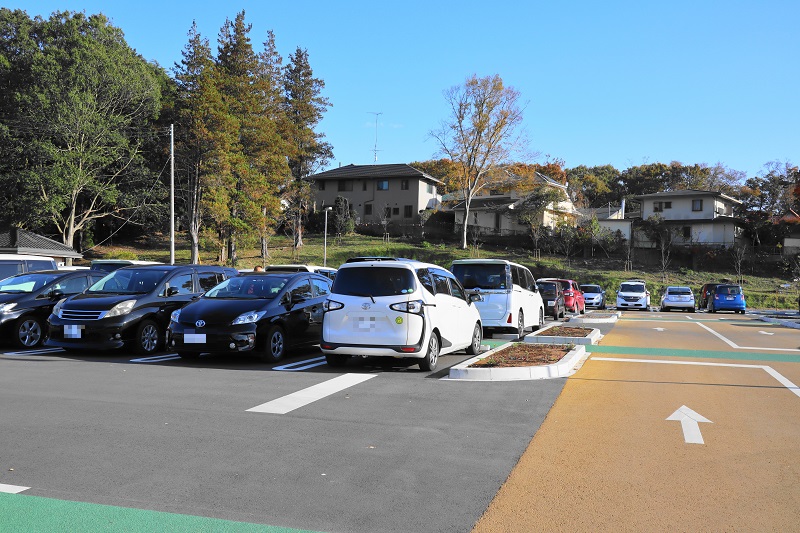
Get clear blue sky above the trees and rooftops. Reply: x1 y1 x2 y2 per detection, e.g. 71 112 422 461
4 0 800 176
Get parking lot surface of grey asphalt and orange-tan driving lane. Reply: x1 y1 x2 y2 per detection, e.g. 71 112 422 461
0 311 800 532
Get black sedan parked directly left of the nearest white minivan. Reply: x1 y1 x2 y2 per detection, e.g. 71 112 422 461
168 272 331 363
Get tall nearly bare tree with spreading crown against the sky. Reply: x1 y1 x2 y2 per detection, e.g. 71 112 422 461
430 75 525 249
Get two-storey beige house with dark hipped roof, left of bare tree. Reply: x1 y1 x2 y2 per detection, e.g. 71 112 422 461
308 164 442 220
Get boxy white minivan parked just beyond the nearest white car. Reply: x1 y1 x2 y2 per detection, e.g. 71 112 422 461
450 259 545 337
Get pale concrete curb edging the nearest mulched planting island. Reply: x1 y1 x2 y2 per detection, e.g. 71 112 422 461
448 343 589 381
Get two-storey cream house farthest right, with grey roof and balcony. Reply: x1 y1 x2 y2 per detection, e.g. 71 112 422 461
634 189 742 248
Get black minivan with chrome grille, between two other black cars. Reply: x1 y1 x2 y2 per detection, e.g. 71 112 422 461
45 265 228 355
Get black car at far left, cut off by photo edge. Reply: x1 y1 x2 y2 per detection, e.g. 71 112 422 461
0 270 106 348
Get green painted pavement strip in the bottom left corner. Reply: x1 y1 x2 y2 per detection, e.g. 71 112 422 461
0 493 324 533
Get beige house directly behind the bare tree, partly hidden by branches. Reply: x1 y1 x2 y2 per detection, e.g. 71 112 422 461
450 172 580 235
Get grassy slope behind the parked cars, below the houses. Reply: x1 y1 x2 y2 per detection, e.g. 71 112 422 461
83 231 798 309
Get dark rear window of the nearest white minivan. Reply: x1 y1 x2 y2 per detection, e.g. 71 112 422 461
331 267 416 296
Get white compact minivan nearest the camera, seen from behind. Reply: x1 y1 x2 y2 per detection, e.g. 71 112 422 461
320 258 482 370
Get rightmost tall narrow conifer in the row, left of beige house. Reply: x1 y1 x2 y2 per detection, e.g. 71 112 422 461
284 47 333 249
